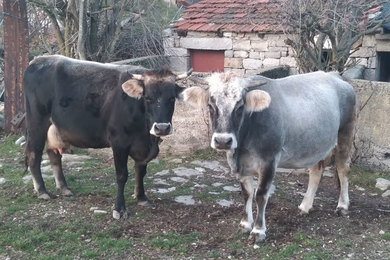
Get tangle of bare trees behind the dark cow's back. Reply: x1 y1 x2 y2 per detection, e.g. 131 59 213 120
27 0 175 62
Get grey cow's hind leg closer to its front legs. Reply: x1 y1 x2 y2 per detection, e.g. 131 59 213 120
298 161 325 214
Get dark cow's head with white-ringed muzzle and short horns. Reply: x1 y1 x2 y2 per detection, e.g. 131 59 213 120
122 69 191 136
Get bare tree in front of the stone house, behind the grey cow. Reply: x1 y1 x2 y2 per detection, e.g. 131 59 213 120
280 0 390 72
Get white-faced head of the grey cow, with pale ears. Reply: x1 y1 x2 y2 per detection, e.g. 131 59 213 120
182 73 271 150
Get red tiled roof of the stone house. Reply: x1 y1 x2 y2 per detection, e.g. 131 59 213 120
174 0 283 33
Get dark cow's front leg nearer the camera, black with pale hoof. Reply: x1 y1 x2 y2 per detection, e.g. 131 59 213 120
112 147 129 219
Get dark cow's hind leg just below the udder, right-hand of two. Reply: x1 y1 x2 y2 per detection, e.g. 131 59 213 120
46 149 73 196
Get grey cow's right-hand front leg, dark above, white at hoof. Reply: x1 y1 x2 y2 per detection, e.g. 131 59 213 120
249 162 276 248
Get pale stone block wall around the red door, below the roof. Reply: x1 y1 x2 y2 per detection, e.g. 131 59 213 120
164 29 296 76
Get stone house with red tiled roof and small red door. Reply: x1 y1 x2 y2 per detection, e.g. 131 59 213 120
164 0 390 81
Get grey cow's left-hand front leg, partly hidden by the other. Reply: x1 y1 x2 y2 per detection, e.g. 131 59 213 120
239 176 254 232
